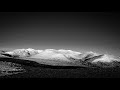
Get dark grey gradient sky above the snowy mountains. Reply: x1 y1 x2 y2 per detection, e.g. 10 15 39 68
0 12 120 55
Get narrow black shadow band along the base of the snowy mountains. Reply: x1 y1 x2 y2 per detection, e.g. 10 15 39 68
0 57 91 69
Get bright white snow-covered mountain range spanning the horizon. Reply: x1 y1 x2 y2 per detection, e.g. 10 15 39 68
3 48 120 63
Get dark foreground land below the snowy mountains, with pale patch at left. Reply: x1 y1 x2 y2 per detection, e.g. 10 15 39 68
0 58 120 78
